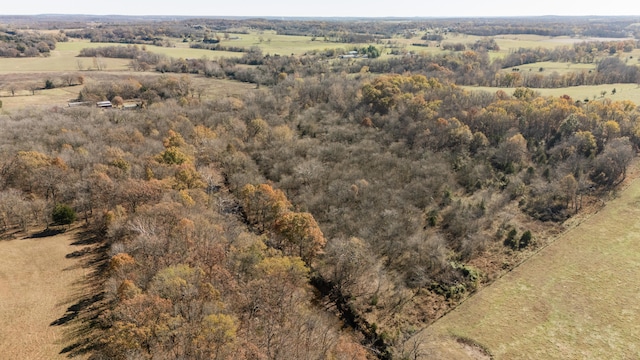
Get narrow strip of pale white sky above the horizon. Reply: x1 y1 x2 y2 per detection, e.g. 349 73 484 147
0 0 640 17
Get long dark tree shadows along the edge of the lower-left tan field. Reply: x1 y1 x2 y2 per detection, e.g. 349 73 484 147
50 230 108 358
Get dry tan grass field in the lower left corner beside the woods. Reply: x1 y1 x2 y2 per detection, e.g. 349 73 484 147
0 232 86 360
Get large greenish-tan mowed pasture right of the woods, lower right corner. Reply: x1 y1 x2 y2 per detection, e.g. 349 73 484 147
409 165 640 359
